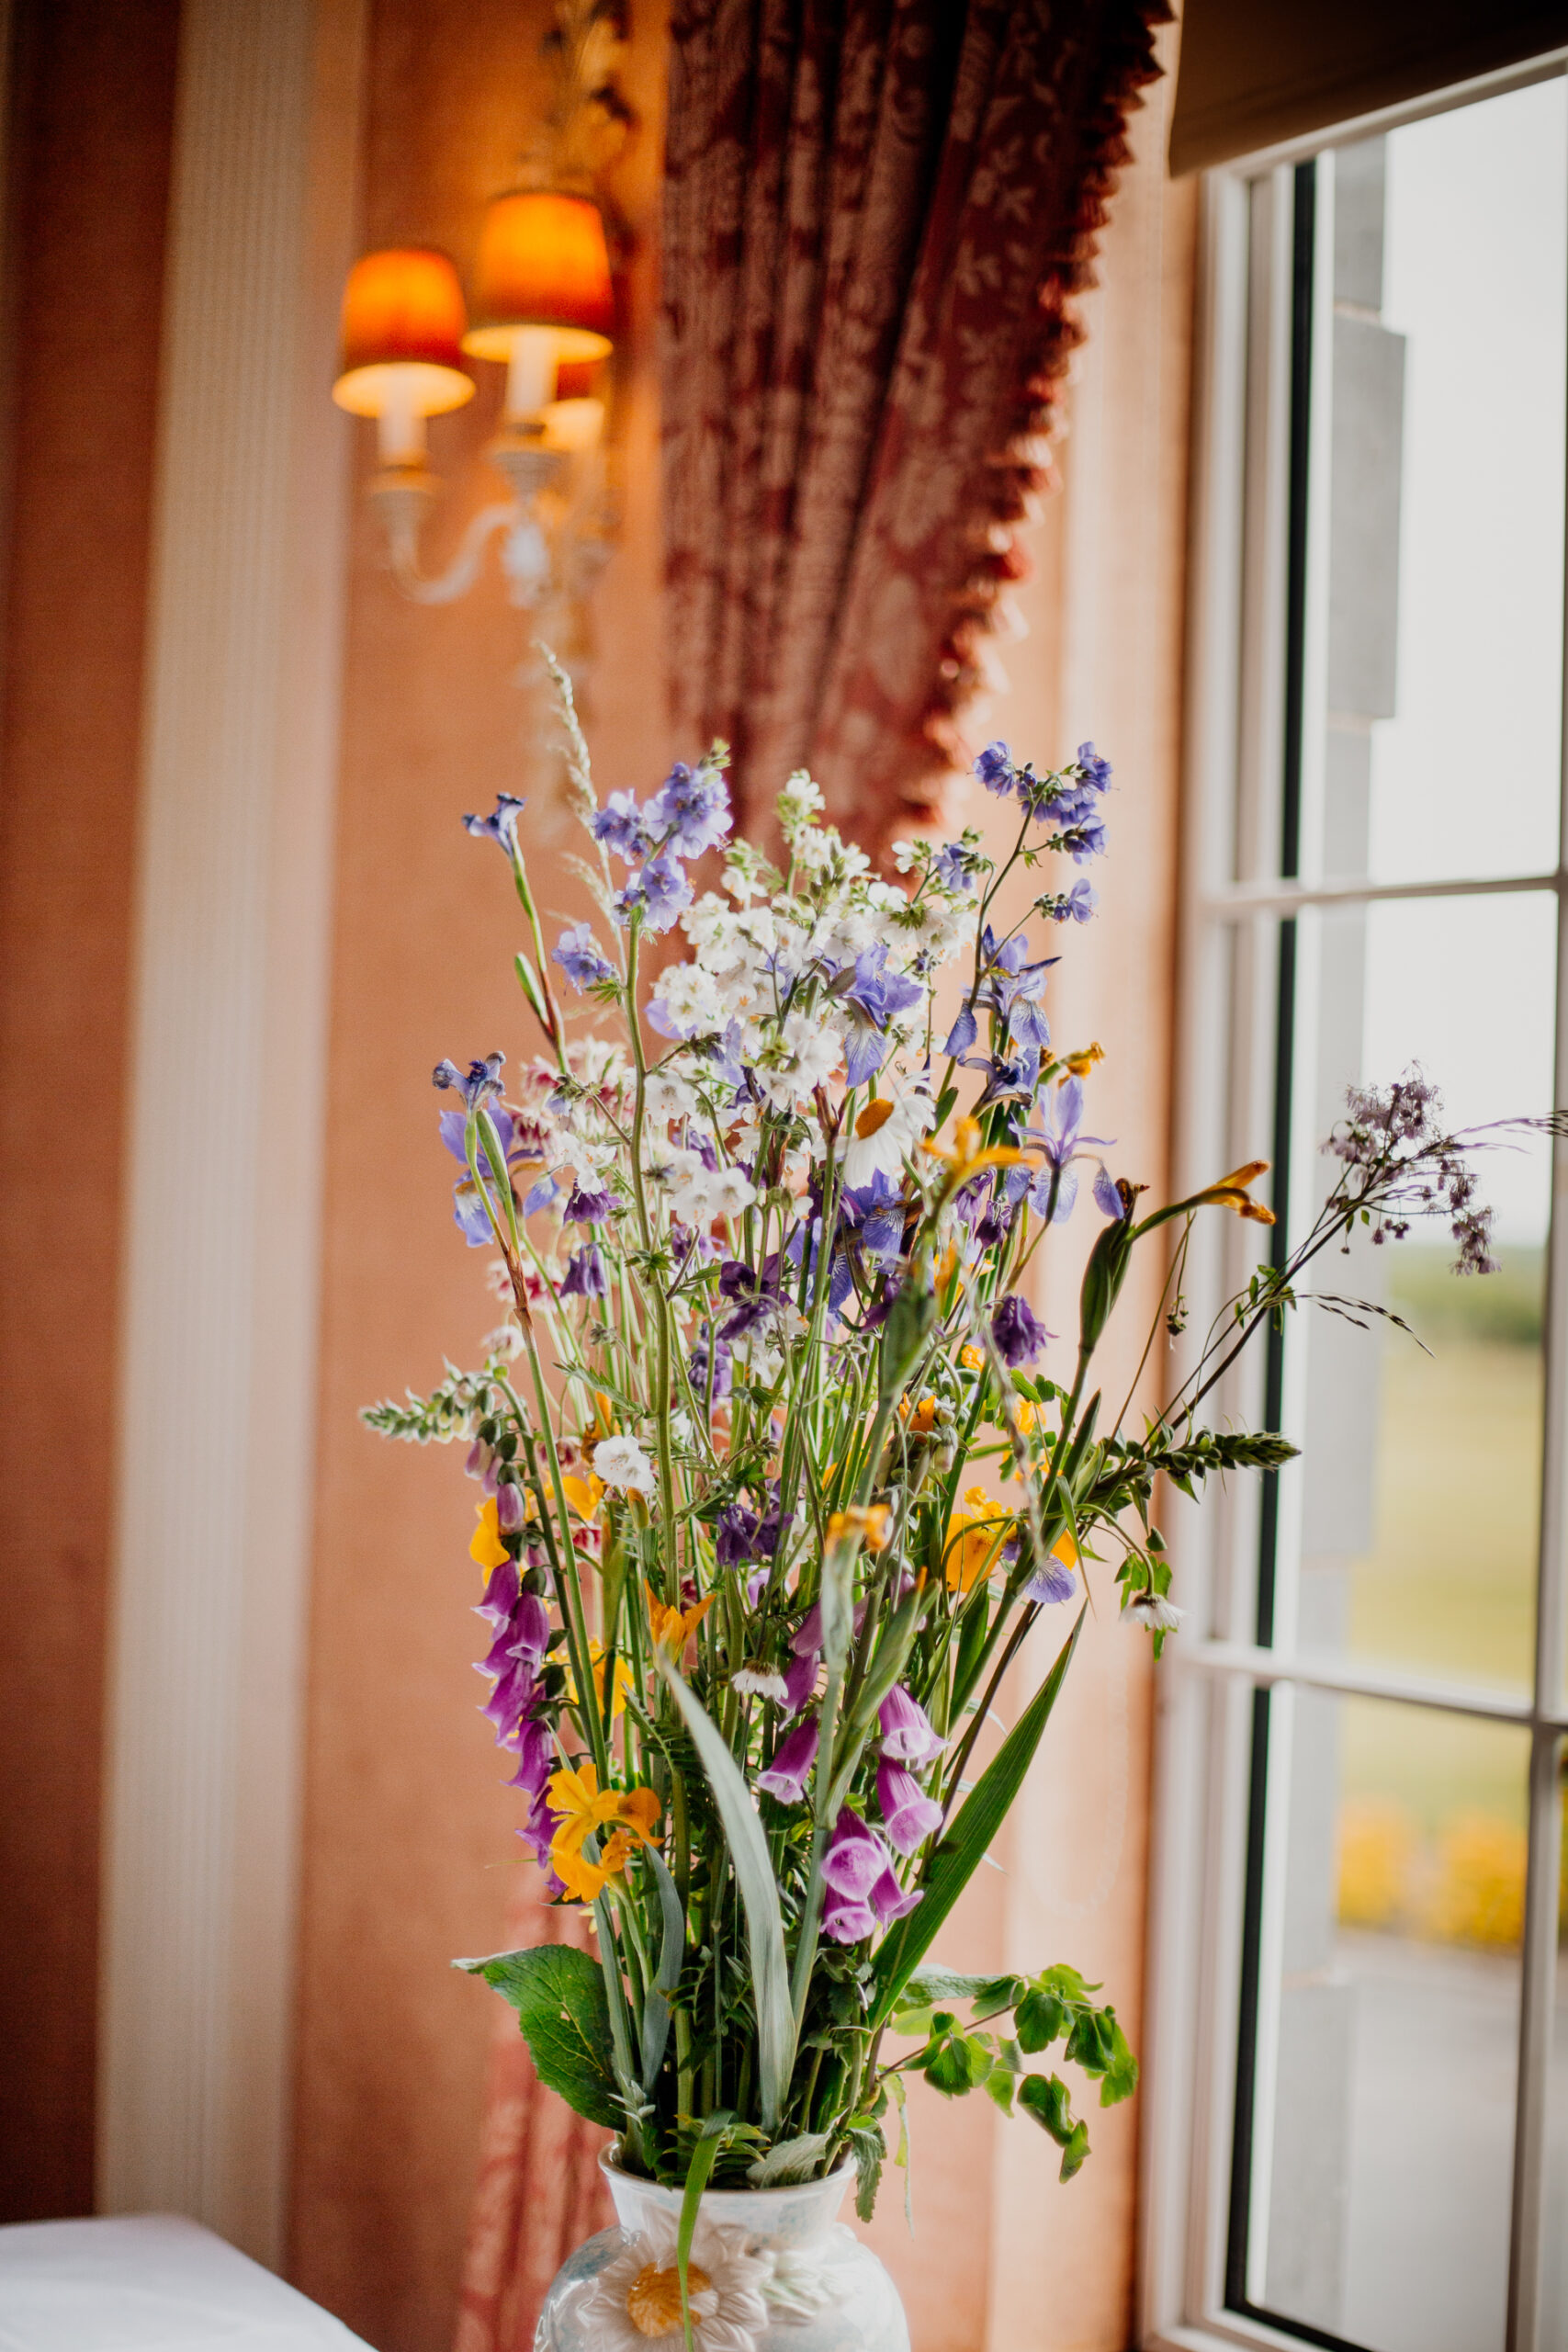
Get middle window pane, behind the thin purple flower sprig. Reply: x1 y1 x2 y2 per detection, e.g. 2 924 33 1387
1281 894 1556 1691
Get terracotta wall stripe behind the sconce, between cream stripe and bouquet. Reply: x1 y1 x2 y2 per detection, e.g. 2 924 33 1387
291 0 670 2352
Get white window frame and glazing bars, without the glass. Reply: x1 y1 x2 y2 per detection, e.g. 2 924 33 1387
1138 50 1568 2352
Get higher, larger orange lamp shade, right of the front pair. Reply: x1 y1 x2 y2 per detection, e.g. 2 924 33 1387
463 188 616 360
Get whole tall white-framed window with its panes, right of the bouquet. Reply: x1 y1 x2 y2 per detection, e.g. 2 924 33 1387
1145 59 1568 2352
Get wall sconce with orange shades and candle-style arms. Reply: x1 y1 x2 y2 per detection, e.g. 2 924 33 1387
332 0 630 625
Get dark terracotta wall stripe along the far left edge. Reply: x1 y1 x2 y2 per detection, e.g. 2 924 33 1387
0 0 179 2221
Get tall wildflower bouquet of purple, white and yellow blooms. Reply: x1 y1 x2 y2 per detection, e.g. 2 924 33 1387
367 668 1523 2213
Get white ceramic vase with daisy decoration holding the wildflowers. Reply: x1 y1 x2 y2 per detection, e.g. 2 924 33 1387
534 2159 909 2352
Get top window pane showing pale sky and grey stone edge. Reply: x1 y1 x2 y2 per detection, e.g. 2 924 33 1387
1303 80 1568 879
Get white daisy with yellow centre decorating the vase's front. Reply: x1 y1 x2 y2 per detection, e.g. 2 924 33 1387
573 2211 771 2352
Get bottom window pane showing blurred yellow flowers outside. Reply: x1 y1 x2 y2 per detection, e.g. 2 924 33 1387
1241 1689 1528 2352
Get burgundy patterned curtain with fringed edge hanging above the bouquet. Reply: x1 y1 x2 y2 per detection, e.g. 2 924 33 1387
660 0 1170 847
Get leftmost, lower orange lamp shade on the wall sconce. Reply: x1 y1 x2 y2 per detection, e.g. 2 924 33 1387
332 244 475 416
